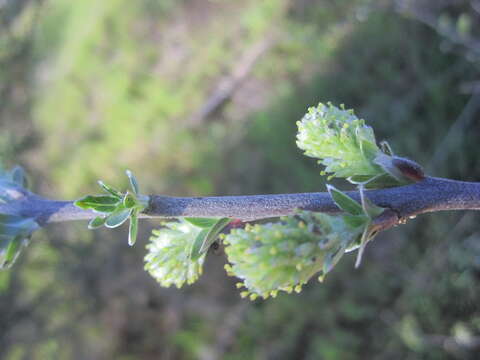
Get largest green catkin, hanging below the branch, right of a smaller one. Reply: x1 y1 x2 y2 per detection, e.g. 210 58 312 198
224 211 362 299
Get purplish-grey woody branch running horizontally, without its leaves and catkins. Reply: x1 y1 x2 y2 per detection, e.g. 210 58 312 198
0 177 480 225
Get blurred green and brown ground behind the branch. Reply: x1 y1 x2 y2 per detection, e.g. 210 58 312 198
0 0 480 360
